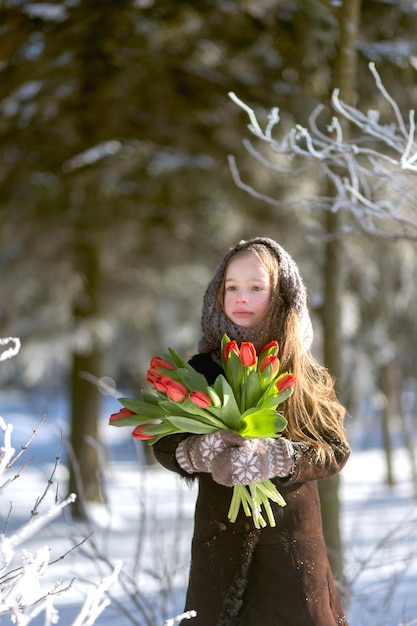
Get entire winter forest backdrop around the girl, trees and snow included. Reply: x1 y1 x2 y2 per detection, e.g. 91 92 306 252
0 0 417 626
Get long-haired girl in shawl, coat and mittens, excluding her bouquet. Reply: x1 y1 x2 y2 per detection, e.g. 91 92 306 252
154 237 349 626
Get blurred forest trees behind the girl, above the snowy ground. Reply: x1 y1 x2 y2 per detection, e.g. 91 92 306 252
0 0 417 604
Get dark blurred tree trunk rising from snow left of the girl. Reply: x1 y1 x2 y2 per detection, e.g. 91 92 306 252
69 223 102 517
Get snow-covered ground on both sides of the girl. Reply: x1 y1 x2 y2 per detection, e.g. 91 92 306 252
0 392 417 626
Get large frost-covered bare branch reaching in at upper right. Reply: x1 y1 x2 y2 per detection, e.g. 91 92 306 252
229 63 417 240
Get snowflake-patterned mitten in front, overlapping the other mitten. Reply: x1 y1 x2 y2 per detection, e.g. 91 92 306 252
211 437 294 487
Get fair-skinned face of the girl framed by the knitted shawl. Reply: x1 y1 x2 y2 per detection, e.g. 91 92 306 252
223 252 271 328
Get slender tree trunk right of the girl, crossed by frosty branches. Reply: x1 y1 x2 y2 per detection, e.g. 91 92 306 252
320 0 361 589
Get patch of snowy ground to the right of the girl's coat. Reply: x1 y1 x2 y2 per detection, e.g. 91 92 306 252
341 449 417 626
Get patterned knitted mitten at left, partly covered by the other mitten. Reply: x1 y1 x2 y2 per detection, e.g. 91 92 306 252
175 430 248 474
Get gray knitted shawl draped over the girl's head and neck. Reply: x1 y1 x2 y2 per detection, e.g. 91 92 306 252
198 237 313 361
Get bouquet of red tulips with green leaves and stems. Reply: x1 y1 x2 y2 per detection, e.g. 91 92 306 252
110 335 295 528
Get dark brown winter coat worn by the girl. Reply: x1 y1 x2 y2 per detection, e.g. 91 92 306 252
154 355 349 626
